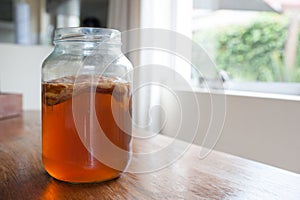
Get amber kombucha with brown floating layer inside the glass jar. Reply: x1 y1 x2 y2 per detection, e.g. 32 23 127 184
42 75 131 182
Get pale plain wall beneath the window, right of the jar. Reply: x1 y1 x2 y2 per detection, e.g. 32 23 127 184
162 92 300 173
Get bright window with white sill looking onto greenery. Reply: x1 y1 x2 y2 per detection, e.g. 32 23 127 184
192 0 300 95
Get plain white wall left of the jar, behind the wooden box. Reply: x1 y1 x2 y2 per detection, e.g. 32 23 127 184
0 44 53 110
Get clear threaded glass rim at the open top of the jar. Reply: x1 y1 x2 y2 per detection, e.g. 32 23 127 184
54 27 121 45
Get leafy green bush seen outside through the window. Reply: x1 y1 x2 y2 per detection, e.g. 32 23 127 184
216 14 300 82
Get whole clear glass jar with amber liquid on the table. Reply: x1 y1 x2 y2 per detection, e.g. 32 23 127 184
42 28 133 182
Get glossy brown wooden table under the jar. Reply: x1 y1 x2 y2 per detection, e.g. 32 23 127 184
0 111 300 200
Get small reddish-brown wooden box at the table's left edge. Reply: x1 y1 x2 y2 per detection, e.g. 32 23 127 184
0 93 22 120
